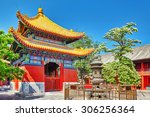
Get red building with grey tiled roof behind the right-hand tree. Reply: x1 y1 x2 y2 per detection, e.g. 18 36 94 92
101 44 150 90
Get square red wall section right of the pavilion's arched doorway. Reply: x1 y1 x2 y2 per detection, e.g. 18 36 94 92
64 68 78 82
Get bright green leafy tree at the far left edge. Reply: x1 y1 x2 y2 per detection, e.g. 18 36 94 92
0 31 24 81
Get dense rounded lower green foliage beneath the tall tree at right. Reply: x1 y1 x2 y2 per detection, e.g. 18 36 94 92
102 57 140 85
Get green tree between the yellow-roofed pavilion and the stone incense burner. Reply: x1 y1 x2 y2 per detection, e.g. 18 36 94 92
71 36 105 79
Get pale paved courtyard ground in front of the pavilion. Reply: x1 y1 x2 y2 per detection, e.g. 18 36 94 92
0 87 150 100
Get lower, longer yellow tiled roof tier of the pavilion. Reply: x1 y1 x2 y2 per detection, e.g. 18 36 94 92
9 28 94 56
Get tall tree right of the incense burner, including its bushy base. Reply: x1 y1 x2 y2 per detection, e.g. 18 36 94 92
102 23 140 85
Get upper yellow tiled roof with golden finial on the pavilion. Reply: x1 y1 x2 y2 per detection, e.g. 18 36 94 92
17 8 84 39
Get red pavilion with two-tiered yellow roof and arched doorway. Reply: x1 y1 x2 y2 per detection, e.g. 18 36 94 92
9 8 94 93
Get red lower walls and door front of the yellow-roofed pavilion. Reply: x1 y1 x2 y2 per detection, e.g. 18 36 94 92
11 64 78 91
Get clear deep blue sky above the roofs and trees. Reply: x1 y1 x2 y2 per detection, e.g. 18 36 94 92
0 0 150 46
